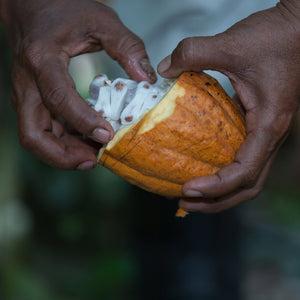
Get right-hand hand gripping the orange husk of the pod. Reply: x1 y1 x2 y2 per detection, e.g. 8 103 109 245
158 0 300 213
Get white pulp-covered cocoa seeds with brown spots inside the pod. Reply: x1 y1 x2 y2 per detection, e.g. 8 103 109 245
87 74 174 133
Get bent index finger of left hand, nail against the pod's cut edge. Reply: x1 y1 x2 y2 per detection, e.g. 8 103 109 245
35 55 114 144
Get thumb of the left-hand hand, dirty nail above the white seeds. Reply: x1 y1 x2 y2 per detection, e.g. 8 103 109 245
93 8 157 83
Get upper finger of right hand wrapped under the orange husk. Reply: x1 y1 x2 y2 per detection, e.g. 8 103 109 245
183 106 289 198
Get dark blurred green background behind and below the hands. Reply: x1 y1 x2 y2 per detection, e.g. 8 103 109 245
0 9 300 300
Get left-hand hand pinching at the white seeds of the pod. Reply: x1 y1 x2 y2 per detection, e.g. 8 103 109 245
0 0 156 169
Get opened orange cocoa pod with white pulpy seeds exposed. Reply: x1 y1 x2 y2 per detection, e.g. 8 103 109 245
89 72 246 197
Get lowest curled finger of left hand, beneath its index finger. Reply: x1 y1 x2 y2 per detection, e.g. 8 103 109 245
15 69 96 169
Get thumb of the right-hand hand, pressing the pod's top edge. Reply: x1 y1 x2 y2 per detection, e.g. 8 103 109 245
157 35 230 78
